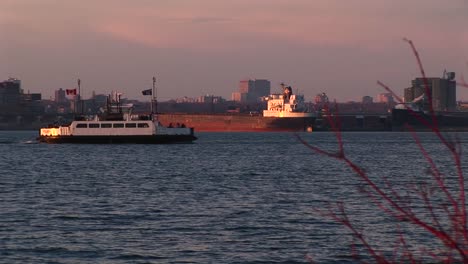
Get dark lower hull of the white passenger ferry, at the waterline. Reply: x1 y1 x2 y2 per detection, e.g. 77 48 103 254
37 135 197 144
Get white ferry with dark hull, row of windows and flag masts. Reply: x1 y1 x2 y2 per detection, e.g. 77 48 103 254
37 78 197 144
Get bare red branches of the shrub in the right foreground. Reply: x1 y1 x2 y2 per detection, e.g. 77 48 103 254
296 39 468 263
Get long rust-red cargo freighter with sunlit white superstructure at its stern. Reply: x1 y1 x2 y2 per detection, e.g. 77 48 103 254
158 84 316 132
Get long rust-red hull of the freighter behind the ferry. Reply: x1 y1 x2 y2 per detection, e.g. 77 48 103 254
158 114 315 132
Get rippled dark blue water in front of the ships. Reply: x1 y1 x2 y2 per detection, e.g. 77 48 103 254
0 131 468 263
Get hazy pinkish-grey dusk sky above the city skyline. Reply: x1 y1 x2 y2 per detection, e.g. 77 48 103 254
0 0 468 101
